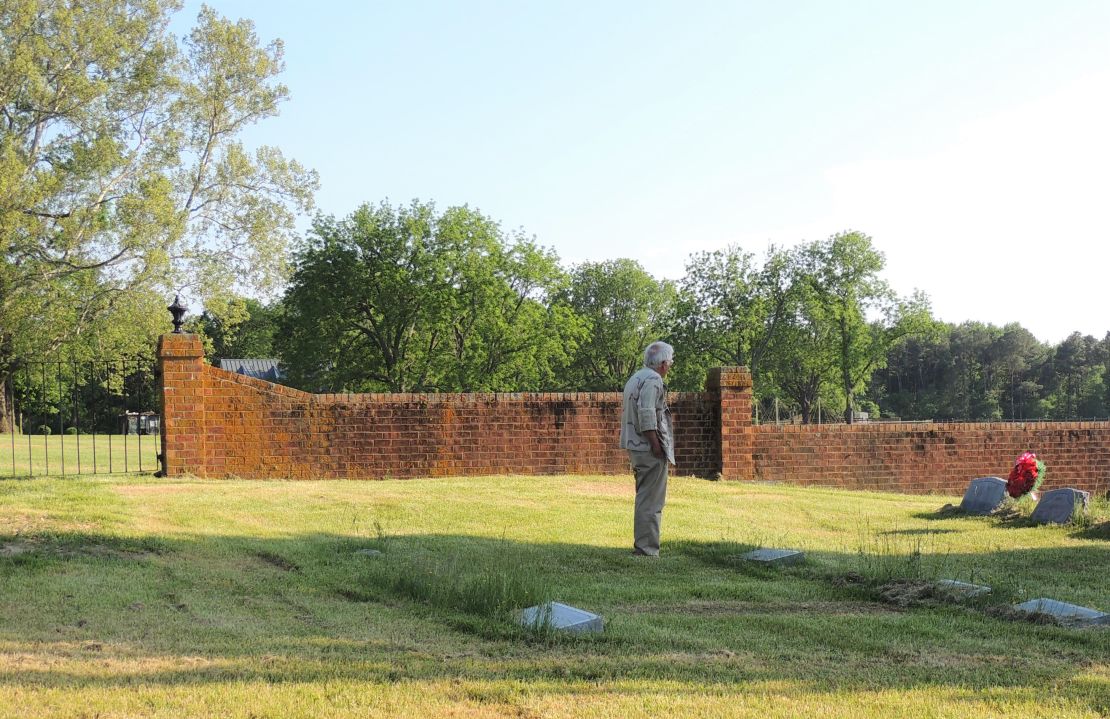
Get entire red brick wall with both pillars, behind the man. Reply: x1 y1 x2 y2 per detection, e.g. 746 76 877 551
159 334 1110 494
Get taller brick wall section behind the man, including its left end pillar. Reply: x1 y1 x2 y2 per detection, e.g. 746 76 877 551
160 335 719 478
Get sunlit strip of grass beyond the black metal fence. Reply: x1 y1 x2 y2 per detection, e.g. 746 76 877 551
0 434 161 477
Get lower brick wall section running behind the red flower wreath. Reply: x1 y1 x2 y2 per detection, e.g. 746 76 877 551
755 422 1110 494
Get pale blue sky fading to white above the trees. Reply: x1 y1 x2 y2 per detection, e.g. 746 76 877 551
181 0 1110 342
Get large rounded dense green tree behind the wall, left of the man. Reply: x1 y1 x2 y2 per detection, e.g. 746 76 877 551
280 202 583 392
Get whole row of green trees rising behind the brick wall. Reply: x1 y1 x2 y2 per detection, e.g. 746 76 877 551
192 202 1110 422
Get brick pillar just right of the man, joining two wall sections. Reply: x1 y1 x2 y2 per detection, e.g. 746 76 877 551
706 367 756 479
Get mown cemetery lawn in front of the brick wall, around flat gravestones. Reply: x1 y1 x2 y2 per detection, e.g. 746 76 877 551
0 477 1110 719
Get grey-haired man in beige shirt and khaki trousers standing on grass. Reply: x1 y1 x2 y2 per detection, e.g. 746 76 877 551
620 342 675 557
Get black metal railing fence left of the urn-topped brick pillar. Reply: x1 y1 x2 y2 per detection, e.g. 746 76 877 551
0 360 161 477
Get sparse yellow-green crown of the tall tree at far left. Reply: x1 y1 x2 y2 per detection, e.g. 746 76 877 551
0 0 316 428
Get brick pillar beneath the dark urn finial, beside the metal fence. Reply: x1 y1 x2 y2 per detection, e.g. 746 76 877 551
158 334 205 477
